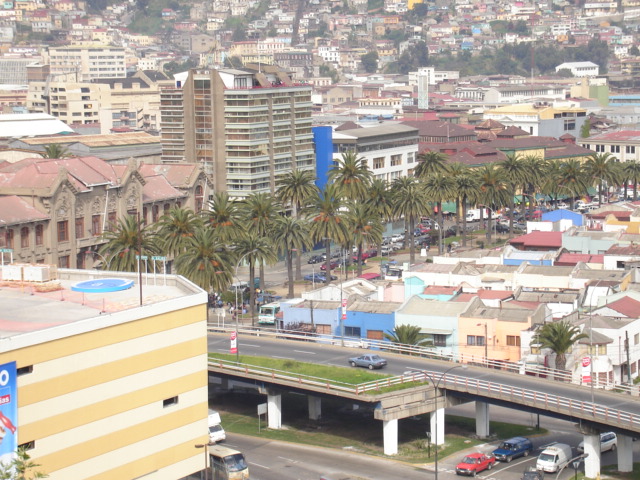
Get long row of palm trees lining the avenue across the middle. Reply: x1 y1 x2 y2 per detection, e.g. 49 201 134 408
99 152 640 313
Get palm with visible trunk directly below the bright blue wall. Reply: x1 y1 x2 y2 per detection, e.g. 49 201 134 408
308 183 347 283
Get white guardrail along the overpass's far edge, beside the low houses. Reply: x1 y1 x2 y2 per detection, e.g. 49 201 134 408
209 324 638 394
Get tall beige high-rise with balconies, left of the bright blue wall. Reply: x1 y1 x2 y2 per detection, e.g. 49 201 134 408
161 65 314 198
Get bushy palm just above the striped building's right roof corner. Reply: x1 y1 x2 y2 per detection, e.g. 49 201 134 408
176 226 233 292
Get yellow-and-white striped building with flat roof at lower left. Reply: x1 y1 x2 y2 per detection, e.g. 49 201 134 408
0 270 208 480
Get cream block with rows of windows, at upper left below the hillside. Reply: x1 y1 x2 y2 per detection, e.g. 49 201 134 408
49 46 127 82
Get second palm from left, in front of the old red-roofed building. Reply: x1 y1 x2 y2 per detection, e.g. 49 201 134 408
157 207 202 258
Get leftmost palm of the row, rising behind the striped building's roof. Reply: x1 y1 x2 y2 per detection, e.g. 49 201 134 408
98 215 160 272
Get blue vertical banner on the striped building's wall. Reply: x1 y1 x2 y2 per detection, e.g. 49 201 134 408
0 362 18 463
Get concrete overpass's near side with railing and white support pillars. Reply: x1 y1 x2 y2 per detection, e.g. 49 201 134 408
209 361 640 478
